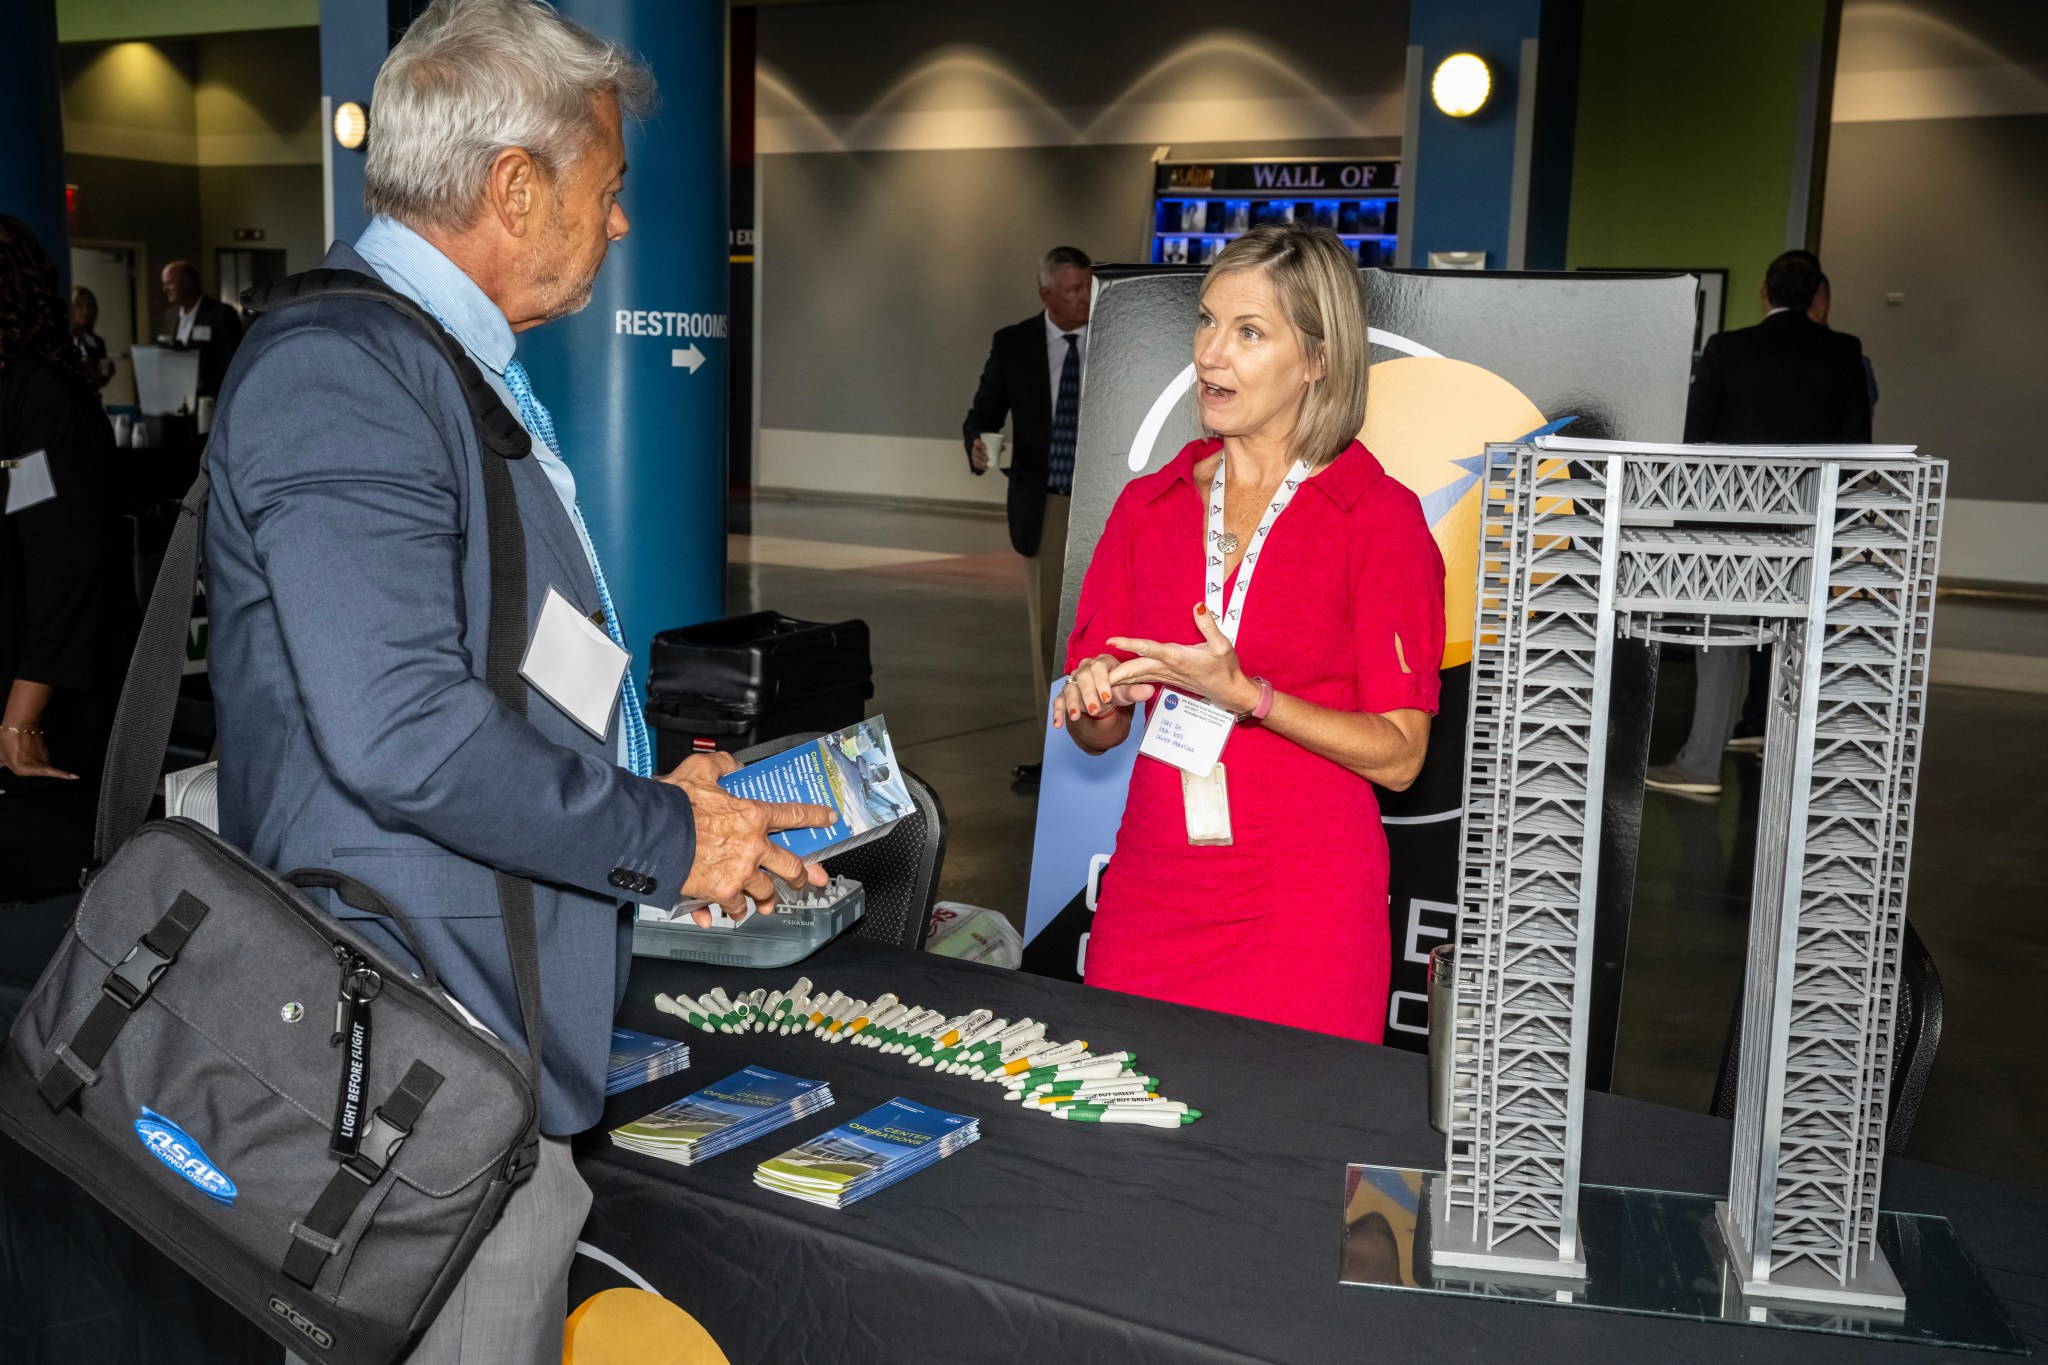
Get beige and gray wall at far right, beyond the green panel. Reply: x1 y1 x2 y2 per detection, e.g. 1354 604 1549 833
1821 0 2048 583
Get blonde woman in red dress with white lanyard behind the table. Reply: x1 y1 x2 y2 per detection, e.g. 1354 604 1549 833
1053 225 1444 1042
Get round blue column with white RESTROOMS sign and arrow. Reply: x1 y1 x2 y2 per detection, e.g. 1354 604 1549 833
516 0 727 663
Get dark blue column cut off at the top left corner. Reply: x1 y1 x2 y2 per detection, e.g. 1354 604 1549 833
0 0 72 289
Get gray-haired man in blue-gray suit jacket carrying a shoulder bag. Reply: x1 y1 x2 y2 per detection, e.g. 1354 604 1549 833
207 0 831 1365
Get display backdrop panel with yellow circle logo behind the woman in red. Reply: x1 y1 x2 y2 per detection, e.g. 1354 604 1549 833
1024 266 1698 1048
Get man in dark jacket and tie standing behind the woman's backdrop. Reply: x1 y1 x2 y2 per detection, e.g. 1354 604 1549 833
961 246 1096 784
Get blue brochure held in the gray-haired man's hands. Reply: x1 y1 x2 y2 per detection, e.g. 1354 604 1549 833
719 716 915 860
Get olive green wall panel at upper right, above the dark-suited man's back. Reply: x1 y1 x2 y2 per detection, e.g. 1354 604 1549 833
1567 0 1829 327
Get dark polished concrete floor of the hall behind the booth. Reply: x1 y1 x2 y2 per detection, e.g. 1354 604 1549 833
729 499 2048 1187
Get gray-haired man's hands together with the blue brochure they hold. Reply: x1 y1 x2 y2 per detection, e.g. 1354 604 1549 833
649 716 915 927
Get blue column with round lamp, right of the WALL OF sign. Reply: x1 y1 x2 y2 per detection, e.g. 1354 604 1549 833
1401 0 1579 270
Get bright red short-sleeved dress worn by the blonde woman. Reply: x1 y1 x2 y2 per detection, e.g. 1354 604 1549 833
1067 440 1444 1042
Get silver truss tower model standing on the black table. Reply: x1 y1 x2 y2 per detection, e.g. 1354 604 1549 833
1432 438 1948 1310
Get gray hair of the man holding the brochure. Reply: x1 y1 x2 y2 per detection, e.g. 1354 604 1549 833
362 0 655 229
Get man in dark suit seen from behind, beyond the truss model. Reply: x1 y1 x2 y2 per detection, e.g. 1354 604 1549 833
1642 252 1870 798
